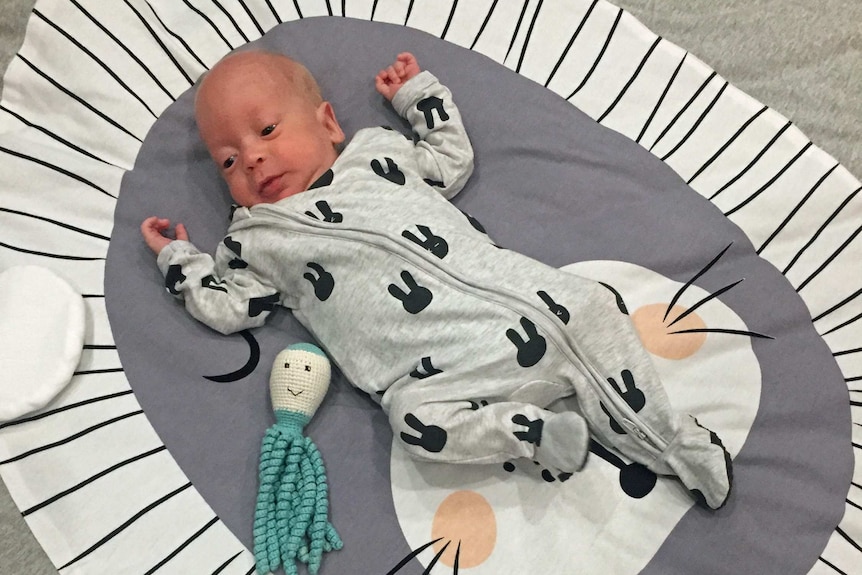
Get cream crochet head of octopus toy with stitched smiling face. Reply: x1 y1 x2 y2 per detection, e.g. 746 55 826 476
269 343 332 419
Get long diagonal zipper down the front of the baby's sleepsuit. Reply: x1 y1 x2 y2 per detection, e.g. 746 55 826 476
253 206 668 455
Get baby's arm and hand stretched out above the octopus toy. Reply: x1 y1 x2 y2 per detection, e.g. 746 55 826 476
141 218 280 334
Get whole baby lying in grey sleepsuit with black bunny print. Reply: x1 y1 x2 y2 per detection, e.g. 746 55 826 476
141 51 732 509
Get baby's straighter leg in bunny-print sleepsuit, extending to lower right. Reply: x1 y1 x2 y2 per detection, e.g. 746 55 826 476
567 285 733 509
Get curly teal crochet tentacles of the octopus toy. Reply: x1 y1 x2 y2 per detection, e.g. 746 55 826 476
254 410 343 575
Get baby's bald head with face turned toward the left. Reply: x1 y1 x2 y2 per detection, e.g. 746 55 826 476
195 51 344 207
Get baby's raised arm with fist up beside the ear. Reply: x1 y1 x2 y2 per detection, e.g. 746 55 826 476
375 52 473 198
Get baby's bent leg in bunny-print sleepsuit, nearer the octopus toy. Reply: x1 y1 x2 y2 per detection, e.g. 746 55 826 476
389 378 589 474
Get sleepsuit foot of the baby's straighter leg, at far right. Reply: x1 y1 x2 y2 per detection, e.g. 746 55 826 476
650 415 733 509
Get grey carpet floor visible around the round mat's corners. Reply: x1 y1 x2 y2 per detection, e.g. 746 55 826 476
0 0 862 575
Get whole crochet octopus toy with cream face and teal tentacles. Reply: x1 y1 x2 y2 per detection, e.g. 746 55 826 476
254 343 342 575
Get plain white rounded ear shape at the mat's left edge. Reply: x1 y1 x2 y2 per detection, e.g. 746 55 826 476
0 265 84 422
